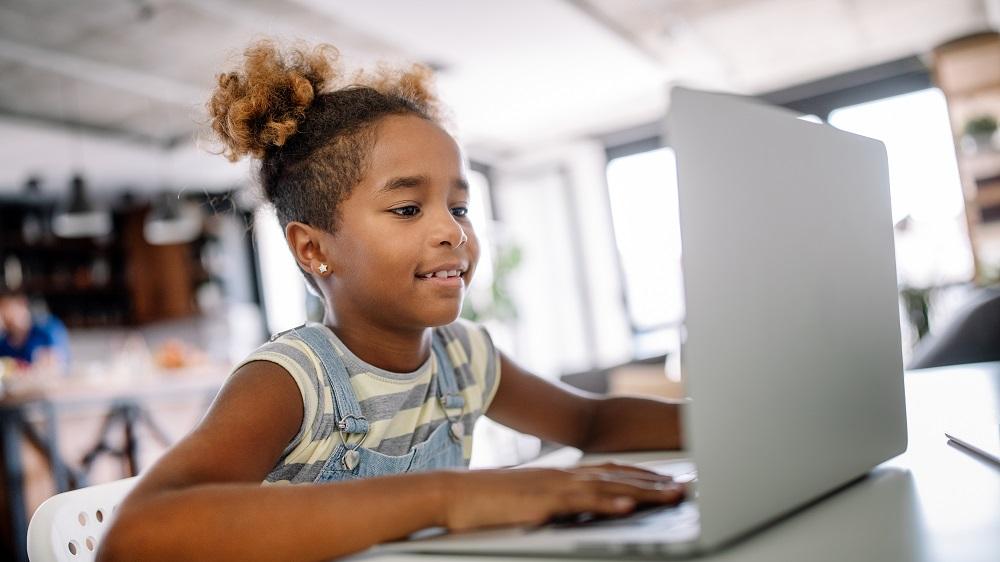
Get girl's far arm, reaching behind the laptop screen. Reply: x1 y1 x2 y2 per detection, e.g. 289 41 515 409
487 353 682 453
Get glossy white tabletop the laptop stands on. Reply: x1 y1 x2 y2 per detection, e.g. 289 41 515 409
351 363 1000 562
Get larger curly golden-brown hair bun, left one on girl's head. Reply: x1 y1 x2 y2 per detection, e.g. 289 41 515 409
208 40 340 161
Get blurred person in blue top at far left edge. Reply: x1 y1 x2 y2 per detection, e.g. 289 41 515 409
0 289 69 368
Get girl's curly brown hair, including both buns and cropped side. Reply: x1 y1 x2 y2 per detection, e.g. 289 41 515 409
207 40 441 232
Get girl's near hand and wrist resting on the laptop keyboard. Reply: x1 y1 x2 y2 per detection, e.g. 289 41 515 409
442 463 684 531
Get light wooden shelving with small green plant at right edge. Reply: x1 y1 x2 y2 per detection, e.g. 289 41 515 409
933 32 1000 281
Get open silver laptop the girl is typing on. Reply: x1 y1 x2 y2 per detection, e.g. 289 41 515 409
381 87 907 558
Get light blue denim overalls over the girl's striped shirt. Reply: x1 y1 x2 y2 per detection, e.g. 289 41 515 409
295 325 465 482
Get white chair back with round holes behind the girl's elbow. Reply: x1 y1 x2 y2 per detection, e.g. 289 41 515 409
28 476 139 562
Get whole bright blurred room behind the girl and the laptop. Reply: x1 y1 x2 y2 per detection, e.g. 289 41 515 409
0 0 1000 557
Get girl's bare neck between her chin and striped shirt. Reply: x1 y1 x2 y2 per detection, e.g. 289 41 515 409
323 317 432 373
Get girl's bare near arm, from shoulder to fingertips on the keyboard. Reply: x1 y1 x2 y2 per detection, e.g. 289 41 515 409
98 362 682 561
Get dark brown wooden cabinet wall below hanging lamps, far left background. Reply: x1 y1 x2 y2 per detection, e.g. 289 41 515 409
0 198 208 327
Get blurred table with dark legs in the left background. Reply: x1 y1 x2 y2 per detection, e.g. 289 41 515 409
0 368 228 561
